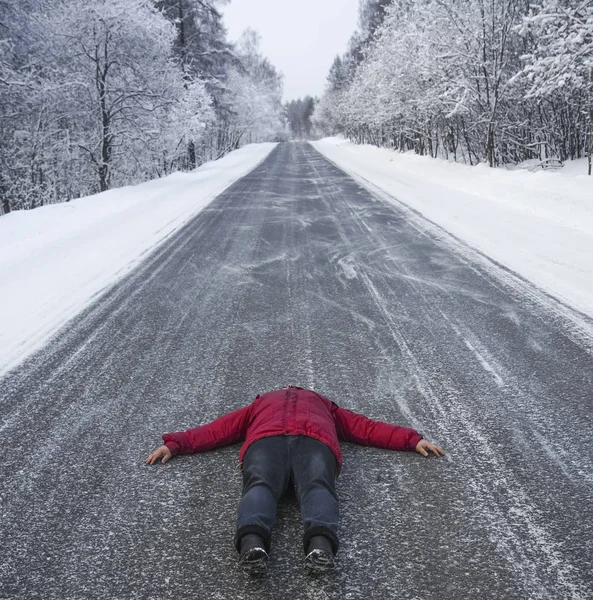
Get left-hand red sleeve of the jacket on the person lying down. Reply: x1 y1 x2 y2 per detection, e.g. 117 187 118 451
163 404 252 456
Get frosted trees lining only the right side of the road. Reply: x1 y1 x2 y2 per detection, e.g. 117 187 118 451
313 0 593 174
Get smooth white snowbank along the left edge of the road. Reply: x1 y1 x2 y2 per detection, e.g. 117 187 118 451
0 143 276 375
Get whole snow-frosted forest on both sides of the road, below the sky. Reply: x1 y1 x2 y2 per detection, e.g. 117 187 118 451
0 0 593 214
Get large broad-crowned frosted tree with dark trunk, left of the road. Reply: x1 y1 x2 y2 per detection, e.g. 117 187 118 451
47 0 214 190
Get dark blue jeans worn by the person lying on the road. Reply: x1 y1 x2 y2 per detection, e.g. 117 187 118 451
235 435 339 553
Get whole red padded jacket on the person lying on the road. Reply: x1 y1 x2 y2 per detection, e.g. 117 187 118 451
163 386 422 467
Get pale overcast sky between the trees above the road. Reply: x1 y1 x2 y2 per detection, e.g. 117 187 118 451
222 0 358 101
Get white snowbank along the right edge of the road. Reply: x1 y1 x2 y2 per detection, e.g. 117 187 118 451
313 137 593 316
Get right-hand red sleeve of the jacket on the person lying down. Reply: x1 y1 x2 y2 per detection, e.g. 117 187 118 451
334 404 422 450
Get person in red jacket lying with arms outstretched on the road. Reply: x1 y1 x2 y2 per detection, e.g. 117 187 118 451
146 385 444 575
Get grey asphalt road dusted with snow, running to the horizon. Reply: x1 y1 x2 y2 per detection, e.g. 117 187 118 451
0 144 593 600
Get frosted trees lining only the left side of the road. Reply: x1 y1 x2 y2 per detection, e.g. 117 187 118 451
0 0 283 213
